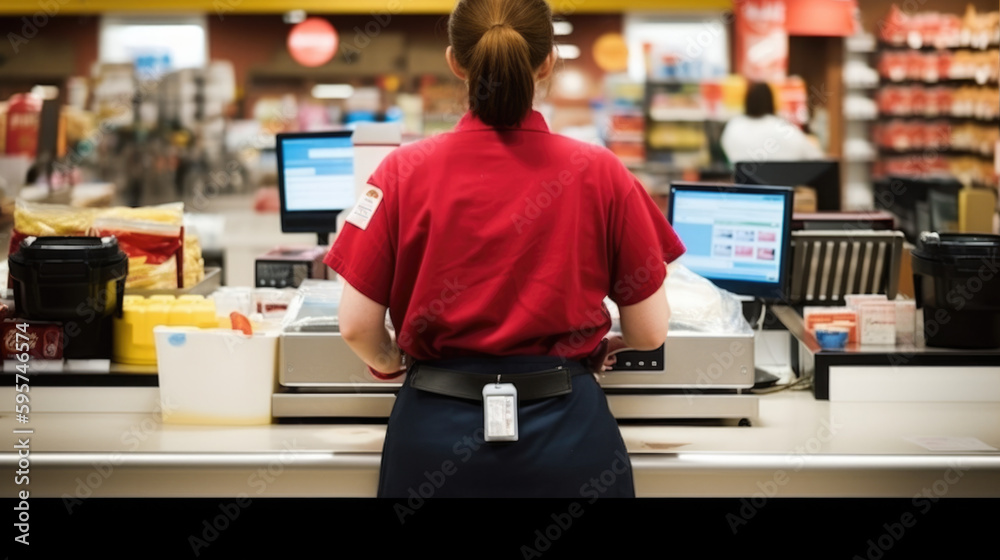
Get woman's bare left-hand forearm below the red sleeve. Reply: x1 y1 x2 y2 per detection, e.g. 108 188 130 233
338 282 402 373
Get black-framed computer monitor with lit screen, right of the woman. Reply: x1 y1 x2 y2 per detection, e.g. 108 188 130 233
667 182 794 301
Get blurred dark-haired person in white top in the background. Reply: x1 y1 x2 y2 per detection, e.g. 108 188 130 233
721 82 825 163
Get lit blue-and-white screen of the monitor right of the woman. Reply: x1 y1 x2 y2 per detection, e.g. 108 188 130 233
671 189 789 285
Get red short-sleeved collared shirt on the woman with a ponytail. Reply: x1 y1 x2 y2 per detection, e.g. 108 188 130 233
325 112 684 360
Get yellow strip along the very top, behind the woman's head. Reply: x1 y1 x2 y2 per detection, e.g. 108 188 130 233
0 0 732 17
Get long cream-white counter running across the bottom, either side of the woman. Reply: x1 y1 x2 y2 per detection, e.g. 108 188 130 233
0 388 1000 500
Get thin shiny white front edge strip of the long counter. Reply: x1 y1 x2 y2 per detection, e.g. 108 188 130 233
7 450 1000 472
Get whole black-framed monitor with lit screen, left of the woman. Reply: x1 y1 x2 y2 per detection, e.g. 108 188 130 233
276 130 355 245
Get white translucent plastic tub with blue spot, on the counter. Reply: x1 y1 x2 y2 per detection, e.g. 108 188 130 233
153 326 278 425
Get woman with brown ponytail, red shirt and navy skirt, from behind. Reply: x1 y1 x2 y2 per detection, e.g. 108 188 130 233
326 0 683 498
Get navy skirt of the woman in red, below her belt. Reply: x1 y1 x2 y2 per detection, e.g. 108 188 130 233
378 356 635 500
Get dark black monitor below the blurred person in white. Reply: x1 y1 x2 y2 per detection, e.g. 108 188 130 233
733 160 840 212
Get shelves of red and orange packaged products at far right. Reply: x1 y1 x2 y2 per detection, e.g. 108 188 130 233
871 6 1000 198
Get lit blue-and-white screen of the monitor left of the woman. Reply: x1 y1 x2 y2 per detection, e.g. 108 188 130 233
281 136 354 212
